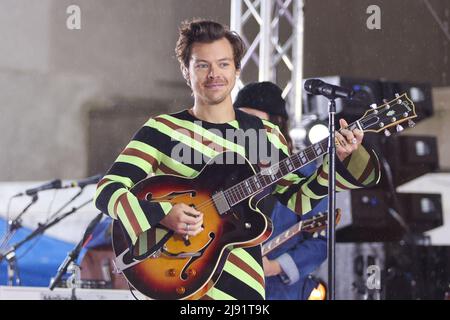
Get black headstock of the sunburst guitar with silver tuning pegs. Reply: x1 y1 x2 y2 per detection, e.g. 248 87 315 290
358 93 417 136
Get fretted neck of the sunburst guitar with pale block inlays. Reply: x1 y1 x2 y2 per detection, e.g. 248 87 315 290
224 121 361 207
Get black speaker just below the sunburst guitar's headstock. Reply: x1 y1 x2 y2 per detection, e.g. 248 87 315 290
380 135 439 186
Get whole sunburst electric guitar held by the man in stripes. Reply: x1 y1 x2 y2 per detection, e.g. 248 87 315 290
113 94 417 299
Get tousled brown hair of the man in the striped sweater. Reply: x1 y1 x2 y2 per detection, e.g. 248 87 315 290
175 19 245 70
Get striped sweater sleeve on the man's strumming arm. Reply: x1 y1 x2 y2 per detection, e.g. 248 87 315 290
94 119 172 249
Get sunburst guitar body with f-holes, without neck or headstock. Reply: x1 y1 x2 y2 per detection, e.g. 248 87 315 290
113 152 272 299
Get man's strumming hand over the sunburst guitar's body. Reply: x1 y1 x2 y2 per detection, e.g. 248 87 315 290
160 203 203 237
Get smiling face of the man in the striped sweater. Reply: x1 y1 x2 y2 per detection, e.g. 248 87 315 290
188 38 239 105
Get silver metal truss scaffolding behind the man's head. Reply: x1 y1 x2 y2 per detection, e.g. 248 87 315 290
230 0 304 126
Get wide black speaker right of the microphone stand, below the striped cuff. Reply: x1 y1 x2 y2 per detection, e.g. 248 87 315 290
336 188 443 242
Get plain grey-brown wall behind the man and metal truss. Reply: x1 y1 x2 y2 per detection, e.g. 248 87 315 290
0 0 450 181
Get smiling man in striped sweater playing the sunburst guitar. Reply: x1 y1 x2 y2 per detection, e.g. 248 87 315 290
94 20 379 300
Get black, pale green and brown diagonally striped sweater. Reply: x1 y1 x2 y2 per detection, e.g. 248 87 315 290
94 110 379 300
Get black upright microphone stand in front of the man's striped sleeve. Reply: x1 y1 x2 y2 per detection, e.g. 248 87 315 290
327 95 336 300
